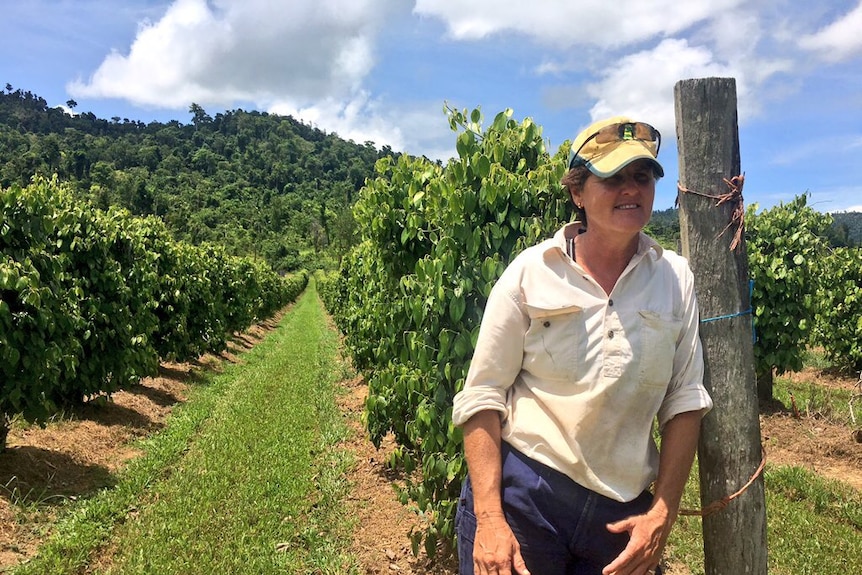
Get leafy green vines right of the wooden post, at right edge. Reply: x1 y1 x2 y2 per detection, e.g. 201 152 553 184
745 195 862 375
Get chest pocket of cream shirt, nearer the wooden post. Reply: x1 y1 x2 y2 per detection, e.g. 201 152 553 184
638 310 682 388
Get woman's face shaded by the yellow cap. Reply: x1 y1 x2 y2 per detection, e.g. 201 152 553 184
572 160 655 235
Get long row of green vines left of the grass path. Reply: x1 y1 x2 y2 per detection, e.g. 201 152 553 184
0 178 308 448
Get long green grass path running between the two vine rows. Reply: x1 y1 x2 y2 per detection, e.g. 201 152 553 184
15 285 357 575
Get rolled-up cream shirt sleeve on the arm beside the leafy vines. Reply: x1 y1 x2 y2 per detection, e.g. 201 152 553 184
452 280 529 426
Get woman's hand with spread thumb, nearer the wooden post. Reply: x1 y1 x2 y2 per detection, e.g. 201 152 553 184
602 510 673 575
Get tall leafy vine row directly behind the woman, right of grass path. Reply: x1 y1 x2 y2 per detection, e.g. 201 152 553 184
318 110 571 555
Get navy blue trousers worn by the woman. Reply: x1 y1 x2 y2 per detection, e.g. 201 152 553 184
455 442 661 575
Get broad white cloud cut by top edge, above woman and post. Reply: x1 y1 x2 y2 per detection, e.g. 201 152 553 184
414 0 743 48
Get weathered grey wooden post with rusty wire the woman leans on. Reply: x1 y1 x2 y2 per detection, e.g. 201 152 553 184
674 78 767 575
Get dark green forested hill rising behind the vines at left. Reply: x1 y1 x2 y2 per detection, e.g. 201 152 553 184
0 84 397 271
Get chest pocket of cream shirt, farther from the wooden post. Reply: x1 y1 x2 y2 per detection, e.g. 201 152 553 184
523 304 584 380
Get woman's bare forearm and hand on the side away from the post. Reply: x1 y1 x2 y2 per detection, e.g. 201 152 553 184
464 410 530 575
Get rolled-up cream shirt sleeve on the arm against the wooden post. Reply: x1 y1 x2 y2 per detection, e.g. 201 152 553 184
658 266 712 429
